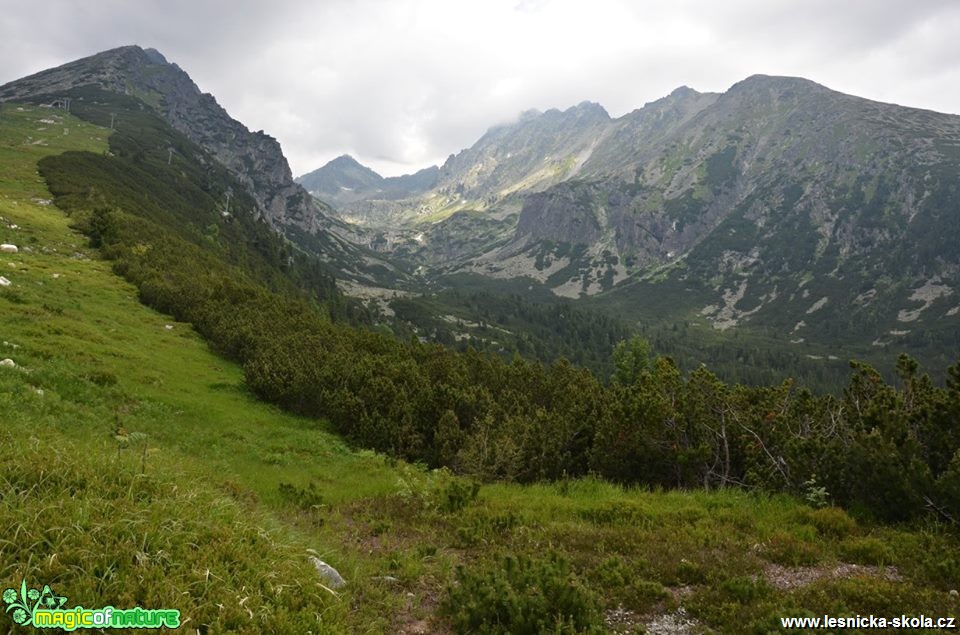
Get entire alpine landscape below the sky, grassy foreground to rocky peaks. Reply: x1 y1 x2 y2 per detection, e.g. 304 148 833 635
0 43 960 635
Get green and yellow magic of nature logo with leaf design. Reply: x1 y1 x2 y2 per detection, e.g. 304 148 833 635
3 580 180 631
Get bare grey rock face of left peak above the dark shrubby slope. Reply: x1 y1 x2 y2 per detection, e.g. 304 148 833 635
0 46 324 232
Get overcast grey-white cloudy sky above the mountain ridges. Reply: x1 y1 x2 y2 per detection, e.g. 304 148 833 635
0 0 960 175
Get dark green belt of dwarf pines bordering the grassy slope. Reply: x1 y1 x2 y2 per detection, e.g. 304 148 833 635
35 89 960 522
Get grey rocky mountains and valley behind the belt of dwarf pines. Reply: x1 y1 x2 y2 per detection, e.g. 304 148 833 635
0 47 960 389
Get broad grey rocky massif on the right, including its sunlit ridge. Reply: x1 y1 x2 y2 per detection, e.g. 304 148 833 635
316 75 960 378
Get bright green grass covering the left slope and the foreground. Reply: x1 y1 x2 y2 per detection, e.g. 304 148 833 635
0 105 960 633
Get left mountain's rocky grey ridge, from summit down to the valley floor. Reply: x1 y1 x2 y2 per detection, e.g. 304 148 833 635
0 46 408 283
